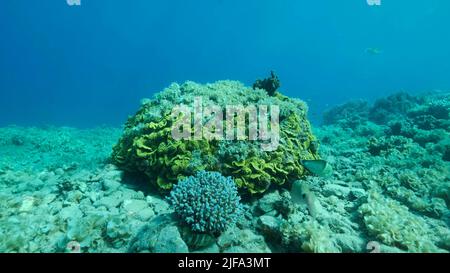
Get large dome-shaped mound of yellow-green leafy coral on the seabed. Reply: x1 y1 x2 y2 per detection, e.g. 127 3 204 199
112 81 319 194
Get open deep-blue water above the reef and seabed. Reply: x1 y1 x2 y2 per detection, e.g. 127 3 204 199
0 0 450 127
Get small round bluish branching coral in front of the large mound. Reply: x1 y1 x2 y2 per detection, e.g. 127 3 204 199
167 171 244 234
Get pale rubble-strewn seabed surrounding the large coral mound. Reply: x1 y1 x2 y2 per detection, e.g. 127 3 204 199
0 94 450 252
